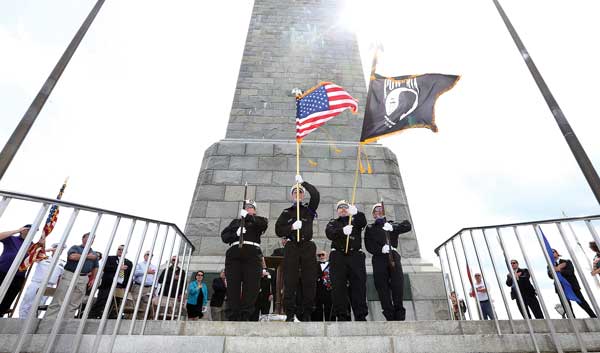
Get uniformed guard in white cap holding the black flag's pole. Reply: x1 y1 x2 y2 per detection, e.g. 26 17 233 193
325 200 369 321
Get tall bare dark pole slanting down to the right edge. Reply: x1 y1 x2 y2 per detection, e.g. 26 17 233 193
493 0 600 203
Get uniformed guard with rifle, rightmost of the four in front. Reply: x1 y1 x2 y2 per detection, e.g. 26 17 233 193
365 203 411 321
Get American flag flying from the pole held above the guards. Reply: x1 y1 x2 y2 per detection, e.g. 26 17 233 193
296 82 358 142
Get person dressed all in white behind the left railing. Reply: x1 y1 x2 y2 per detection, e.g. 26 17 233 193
19 243 65 319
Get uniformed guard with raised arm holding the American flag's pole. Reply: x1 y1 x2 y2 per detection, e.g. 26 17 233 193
275 175 320 322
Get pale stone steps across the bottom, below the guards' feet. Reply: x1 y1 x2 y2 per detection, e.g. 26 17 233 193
0 319 600 353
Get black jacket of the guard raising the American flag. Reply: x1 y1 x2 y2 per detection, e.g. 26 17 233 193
275 181 320 241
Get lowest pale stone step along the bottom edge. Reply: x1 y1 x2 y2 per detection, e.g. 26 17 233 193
0 333 600 353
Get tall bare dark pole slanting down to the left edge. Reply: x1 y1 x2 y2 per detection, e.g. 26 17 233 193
0 0 104 179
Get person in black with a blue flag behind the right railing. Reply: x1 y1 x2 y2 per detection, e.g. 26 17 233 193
544 248 597 318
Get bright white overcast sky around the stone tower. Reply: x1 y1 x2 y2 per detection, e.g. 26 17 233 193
0 0 600 284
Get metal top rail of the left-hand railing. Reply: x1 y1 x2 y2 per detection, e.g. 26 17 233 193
0 190 193 252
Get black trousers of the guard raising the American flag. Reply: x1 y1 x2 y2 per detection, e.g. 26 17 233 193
283 241 317 319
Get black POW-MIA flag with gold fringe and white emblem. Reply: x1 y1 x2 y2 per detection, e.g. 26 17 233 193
360 74 460 143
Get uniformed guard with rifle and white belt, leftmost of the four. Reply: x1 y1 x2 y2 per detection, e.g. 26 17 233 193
221 200 268 321
